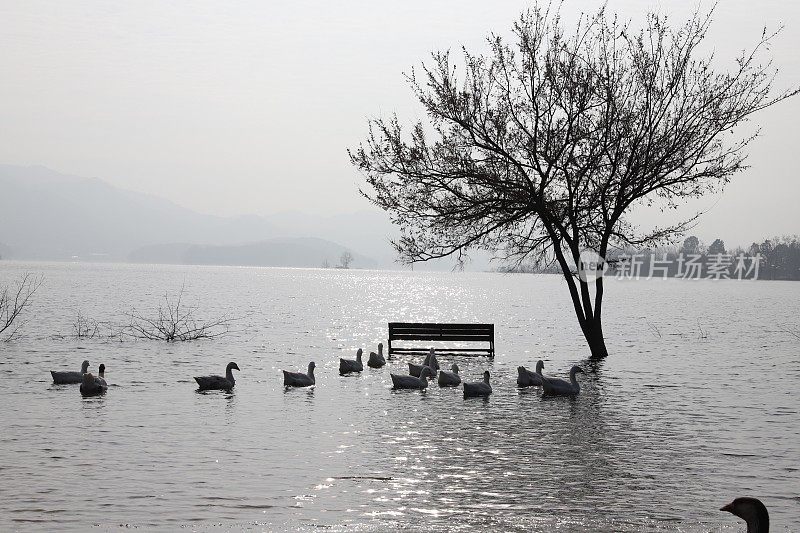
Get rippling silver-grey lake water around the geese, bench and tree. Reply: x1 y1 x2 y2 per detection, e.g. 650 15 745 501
0 262 800 532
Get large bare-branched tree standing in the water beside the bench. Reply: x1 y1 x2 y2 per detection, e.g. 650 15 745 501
350 6 798 358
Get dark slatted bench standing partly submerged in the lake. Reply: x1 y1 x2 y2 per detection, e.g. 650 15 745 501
388 322 494 358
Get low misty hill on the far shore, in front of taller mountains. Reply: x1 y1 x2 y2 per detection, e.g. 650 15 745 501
128 237 378 268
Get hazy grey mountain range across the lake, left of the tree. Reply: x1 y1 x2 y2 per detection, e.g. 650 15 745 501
0 165 394 268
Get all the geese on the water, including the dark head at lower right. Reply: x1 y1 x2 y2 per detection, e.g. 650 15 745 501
50 354 769 533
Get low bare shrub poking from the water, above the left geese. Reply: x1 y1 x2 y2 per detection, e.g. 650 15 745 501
127 286 236 342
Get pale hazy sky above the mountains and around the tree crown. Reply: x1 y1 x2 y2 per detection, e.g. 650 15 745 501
0 0 800 246
